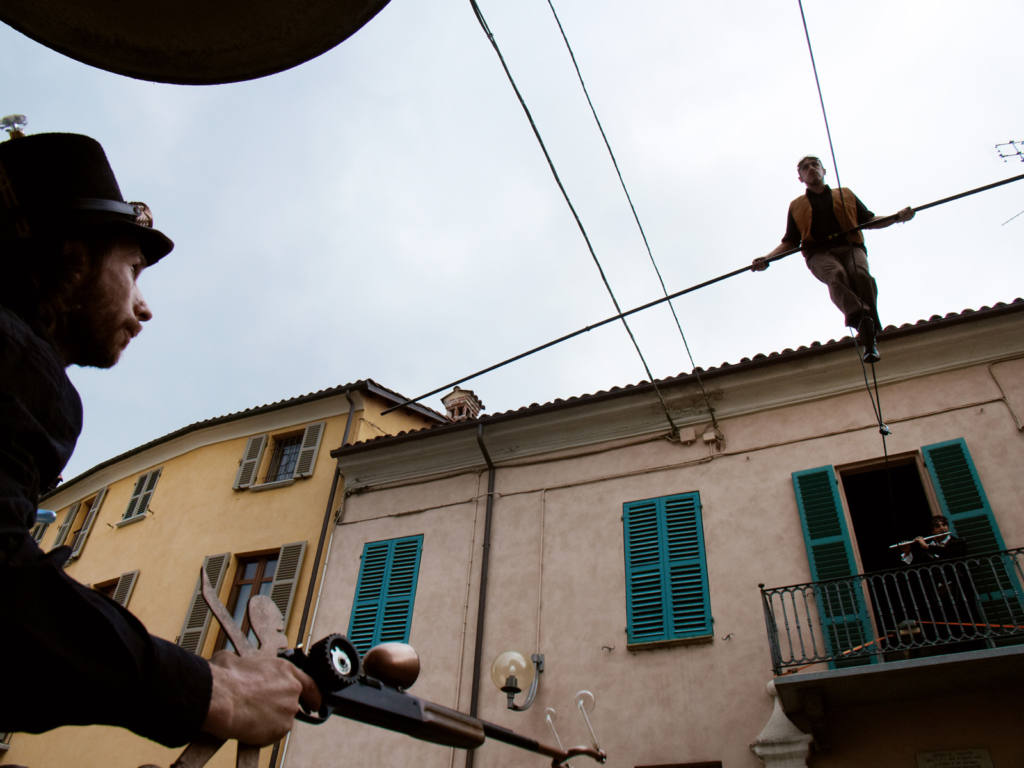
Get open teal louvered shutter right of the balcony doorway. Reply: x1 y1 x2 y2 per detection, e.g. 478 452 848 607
921 438 1024 638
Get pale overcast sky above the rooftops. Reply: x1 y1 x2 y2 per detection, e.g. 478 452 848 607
0 0 1024 478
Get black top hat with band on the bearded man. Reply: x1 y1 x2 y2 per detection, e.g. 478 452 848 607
0 133 174 264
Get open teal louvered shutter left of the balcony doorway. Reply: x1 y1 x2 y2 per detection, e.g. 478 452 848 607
793 467 876 668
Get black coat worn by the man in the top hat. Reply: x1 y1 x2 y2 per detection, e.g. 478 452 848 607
0 306 212 746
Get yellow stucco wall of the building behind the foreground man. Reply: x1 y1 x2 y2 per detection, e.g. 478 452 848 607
6 392 442 768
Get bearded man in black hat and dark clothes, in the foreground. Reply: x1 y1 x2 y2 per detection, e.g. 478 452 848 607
0 133 318 746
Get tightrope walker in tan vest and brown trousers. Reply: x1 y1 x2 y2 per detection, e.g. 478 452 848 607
751 155 913 362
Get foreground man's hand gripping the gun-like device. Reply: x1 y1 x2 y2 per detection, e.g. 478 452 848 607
203 650 321 746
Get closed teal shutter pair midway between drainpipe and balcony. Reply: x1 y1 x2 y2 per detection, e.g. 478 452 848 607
623 493 712 643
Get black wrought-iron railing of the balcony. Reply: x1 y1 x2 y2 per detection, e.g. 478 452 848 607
761 548 1024 675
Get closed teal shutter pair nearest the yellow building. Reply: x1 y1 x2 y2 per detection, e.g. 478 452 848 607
348 535 423 653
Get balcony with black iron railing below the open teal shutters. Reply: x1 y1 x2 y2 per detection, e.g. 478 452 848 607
761 549 1024 729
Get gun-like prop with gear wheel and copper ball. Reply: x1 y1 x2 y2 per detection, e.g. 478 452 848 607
148 570 607 768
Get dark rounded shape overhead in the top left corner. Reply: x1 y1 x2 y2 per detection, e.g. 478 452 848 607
0 0 388 85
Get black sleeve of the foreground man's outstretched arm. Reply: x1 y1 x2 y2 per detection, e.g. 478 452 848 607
0 535 212 746
